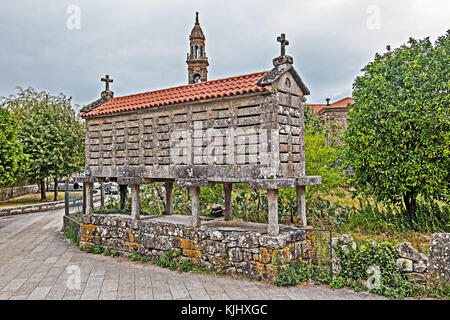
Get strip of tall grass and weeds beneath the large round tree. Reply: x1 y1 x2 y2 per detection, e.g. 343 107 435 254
307 194 450 254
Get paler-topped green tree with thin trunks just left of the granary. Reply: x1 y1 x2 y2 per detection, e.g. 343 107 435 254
3 88 84 200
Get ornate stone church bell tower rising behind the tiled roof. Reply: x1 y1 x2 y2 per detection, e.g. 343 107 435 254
186 12 209 84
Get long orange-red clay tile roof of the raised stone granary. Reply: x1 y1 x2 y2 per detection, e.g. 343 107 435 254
81 71 271 118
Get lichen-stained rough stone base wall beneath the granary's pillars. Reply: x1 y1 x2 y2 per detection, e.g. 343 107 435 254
80 214 313 279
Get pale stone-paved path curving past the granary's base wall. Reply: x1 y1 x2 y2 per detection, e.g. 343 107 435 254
0 210 382 300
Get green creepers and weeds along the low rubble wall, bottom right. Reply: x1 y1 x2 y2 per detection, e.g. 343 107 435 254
275 241 450 299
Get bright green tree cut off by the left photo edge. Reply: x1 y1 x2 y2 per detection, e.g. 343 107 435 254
0 107 28 187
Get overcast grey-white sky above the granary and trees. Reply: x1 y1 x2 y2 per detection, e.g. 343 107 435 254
0 0 450 110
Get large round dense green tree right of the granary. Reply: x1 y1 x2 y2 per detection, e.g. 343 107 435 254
344 31 450 217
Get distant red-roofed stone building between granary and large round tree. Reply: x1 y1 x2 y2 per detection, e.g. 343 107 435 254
309 97 355 142
